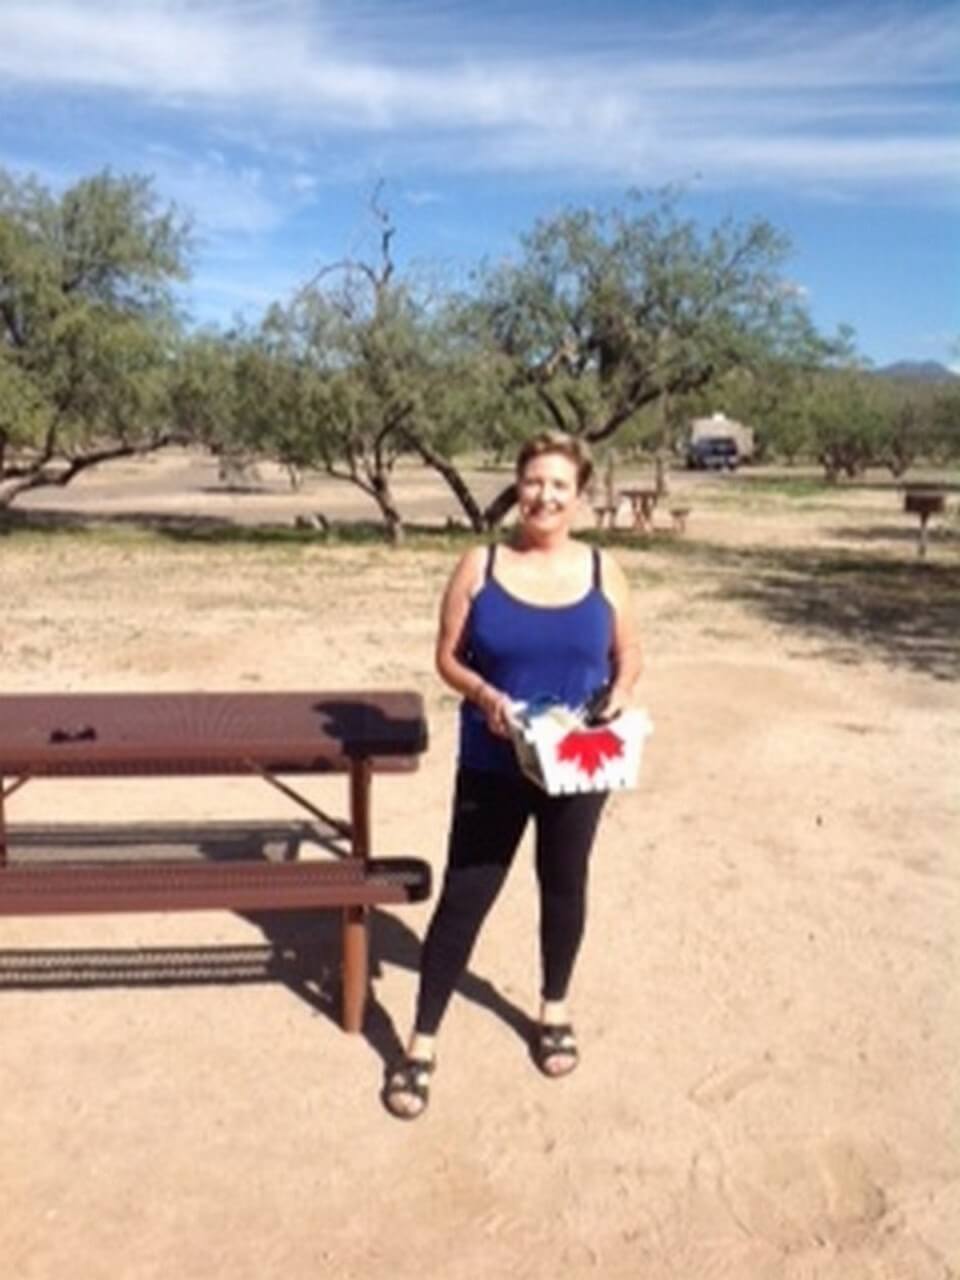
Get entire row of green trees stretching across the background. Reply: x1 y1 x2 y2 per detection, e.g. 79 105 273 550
16 170 960 527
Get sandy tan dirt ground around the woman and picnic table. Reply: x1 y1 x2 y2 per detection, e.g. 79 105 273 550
0 454 960 1280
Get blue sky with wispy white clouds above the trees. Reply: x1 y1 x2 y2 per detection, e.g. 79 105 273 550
0 0 960 367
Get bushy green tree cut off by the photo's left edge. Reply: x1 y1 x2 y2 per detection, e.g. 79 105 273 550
0 170 188 506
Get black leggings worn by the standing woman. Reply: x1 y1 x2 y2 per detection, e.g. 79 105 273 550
415 769 607 1036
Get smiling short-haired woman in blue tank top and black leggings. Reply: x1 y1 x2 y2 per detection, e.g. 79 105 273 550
383 433 640 1120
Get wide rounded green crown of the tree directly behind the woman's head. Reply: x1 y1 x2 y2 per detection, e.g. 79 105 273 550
472 195 831 450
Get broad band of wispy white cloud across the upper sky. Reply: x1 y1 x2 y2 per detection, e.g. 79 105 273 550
0 0 960 195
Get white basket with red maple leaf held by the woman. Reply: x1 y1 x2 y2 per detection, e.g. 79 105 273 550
509 703 653 796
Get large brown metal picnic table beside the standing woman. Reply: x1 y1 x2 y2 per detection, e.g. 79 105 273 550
0 690 430 1032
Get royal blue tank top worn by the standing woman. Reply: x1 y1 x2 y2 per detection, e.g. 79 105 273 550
460 545 613 774
